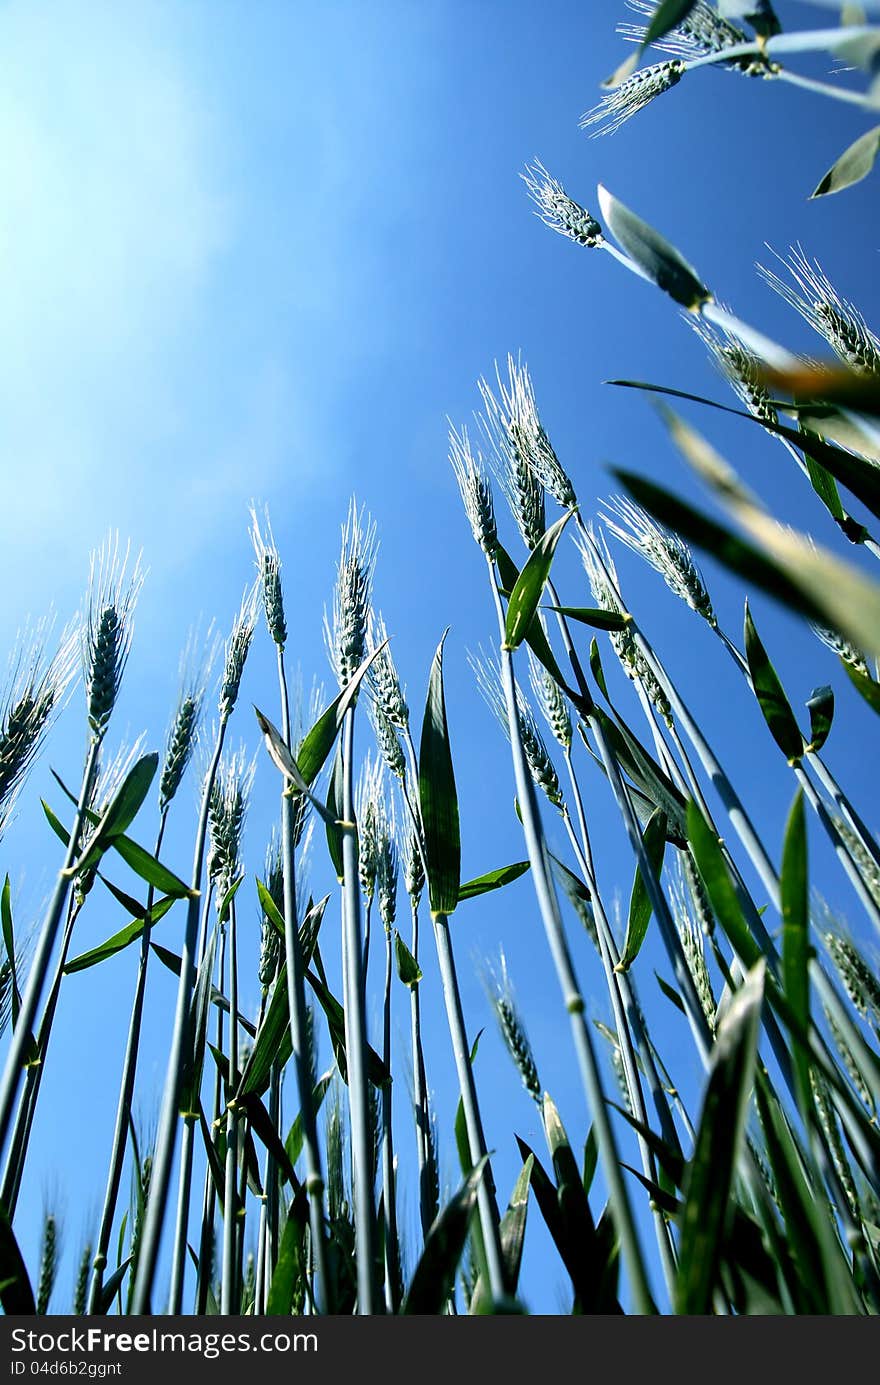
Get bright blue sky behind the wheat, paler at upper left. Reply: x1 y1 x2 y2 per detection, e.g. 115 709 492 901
0 0 880 1312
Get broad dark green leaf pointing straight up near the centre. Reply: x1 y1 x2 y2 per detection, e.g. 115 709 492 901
419 634 461 914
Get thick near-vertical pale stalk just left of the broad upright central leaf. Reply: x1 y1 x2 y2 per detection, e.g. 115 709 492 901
342 708 378 1314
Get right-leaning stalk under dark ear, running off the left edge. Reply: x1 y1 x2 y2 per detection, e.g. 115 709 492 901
0 735 103 1154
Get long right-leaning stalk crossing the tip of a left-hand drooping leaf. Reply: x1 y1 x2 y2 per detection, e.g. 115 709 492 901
132 715 229 1316
